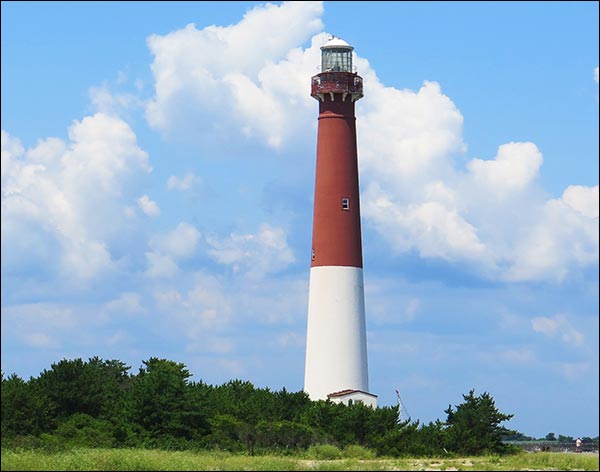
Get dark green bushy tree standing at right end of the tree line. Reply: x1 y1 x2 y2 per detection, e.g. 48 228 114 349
444 390 514 455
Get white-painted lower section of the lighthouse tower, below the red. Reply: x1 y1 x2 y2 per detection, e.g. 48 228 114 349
304 266 369 400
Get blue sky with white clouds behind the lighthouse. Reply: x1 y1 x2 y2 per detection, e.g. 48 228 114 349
0 1 599 437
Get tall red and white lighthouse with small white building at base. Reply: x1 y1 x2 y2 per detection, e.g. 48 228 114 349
304 37 377 407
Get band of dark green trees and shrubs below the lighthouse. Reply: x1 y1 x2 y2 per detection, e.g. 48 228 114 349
1 357 516 457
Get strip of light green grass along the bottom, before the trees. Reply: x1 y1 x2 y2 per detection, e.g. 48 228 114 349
2 449 598 470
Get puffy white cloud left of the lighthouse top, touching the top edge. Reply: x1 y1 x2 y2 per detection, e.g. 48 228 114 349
146 2 323 148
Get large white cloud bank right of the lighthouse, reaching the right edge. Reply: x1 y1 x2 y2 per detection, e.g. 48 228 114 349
357 71 598 281
